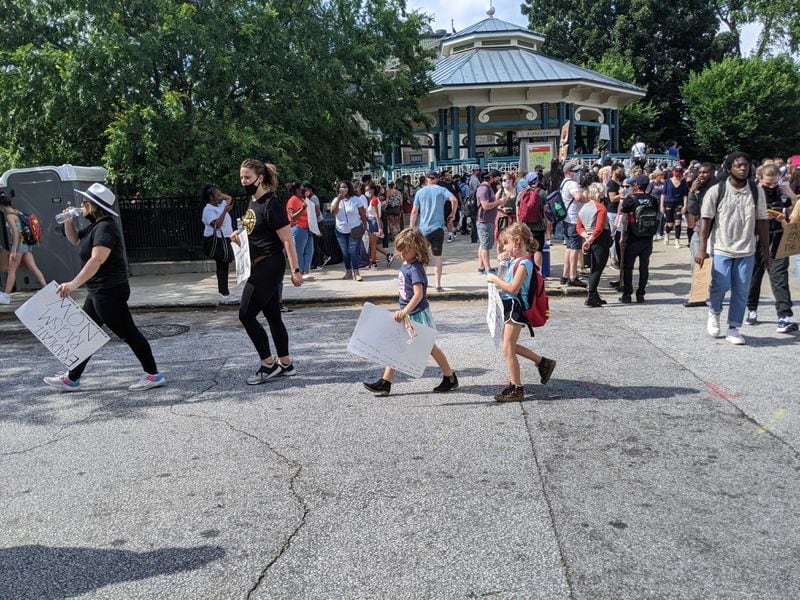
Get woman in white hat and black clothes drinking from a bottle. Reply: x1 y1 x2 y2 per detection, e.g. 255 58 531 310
44 183 166 392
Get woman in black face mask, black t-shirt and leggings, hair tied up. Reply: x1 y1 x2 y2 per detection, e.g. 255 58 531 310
231 158 303 385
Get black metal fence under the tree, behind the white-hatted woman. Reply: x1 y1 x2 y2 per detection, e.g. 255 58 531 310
119 196 246 262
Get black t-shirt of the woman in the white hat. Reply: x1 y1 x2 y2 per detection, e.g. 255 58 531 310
78 217 128 292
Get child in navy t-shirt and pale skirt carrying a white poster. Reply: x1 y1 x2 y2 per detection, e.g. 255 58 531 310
364 229 458 396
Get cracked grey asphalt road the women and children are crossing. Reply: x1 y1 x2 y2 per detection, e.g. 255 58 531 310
0 294 800 600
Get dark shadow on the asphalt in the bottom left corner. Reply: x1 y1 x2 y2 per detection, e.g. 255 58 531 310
0 544 225 598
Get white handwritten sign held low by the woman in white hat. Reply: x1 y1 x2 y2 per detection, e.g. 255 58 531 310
14 281 110 369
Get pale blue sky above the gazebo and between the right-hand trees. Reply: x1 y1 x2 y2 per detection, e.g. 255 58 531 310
408 0 759 55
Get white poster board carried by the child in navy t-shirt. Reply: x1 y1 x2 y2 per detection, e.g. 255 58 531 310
347 302 436 377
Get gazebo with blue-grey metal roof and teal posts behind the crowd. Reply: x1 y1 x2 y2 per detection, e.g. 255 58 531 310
384 9 645 177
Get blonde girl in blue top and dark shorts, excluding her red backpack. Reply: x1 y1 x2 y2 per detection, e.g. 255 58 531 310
486 223 556 402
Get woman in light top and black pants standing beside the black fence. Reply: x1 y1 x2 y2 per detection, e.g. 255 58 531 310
200 185 239 304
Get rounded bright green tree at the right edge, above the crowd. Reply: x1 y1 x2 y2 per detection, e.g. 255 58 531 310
682 56 800 159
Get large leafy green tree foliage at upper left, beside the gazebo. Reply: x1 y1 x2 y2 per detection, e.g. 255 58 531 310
0 0 430 195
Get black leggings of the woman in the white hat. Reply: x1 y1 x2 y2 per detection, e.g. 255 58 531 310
69 283 158 381
